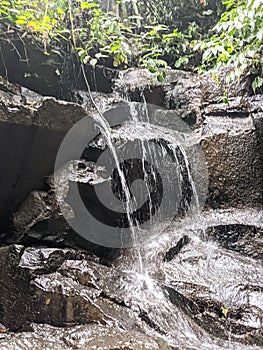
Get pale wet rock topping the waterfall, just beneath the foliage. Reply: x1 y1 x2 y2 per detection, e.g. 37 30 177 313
115 69 201 125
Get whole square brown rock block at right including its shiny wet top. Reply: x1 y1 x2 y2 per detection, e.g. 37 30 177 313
201 96 263 208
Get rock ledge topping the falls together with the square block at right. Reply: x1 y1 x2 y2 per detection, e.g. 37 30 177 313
116 69 263 208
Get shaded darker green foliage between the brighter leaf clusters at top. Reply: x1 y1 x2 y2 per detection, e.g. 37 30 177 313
118 0 222 69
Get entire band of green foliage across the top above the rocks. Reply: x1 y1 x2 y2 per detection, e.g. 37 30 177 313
0 0 263 91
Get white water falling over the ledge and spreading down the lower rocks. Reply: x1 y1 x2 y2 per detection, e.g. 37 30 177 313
76 72 261 350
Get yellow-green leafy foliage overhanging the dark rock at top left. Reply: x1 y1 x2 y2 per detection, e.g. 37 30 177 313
0 0 169 70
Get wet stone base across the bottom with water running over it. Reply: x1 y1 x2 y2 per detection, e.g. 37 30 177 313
0 206 263 350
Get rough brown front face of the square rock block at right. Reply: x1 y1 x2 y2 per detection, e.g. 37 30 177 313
202 130 262 208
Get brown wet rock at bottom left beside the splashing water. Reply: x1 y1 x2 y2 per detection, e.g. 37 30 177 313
0 246 175 350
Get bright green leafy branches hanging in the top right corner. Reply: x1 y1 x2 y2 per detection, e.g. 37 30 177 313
194 0 263 91
